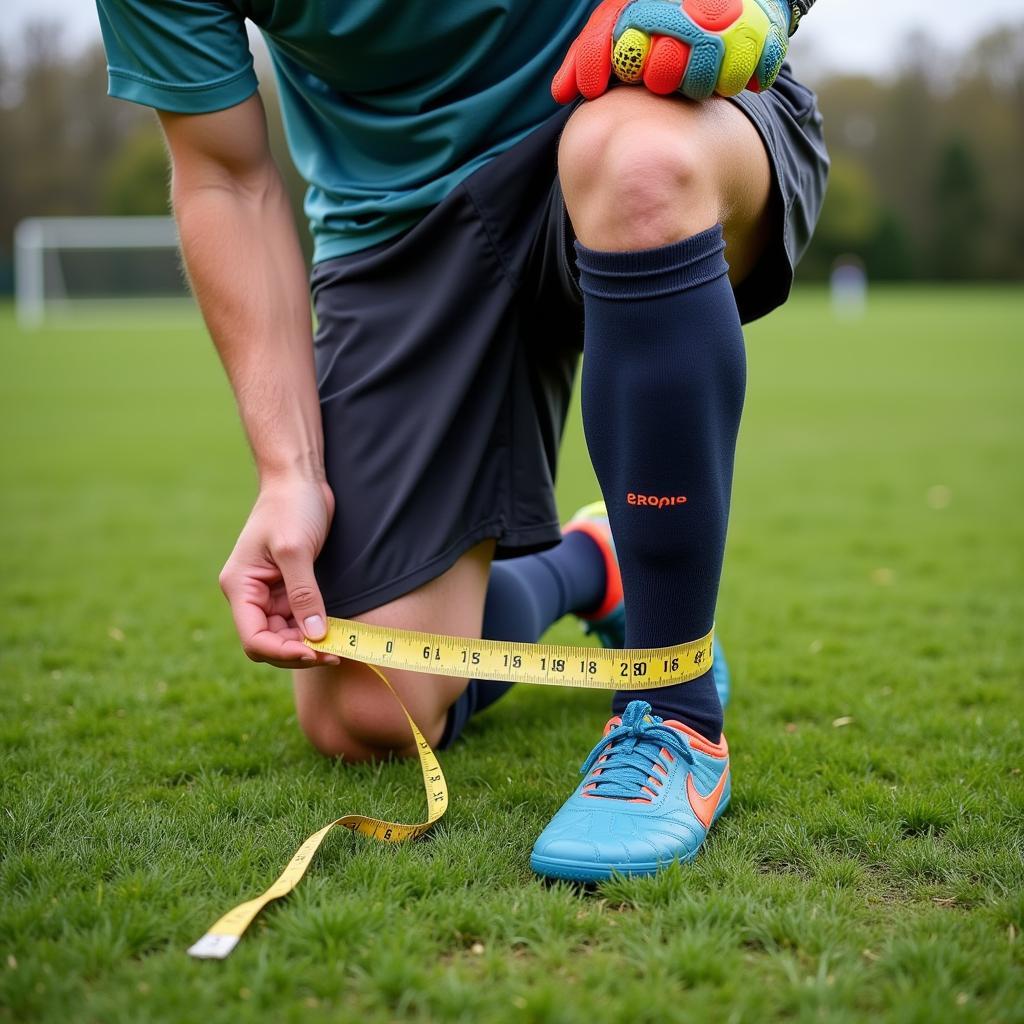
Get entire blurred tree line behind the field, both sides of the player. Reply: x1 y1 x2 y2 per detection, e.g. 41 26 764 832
0 23 1024 292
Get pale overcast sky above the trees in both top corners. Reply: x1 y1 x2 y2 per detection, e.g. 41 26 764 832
0 0 1024 72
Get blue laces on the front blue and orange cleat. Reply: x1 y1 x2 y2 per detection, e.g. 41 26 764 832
580 700 695 803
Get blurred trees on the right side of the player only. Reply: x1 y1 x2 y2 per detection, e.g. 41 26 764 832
801 24 1024 281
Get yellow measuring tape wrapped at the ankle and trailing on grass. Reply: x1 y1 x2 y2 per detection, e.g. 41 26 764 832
188 618 714 959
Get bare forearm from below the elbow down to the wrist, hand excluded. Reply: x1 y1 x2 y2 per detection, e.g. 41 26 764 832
172 156 324 480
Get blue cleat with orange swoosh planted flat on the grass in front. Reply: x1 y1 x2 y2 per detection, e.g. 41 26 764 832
529 700 732 882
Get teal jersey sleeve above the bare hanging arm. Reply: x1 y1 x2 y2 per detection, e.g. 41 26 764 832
96 0 257 114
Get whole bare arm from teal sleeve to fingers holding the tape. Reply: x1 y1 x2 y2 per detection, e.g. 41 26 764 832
160 96 337 667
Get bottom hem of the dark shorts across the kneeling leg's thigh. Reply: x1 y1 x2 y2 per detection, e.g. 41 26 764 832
325 519 561 618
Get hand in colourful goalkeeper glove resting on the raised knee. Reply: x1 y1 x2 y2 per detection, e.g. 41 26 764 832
551 0 790 103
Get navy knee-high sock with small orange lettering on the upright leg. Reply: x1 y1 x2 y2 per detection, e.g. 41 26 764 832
577 226 746 742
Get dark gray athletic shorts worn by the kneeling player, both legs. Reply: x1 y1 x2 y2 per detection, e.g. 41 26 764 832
312 70 827 615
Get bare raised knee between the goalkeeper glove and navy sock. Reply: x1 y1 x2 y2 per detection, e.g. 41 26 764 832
558 88 720 250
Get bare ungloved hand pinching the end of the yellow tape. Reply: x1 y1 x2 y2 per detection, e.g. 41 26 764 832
220 478 341 669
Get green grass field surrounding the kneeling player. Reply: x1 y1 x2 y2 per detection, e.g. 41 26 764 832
0 289 1024 1024
